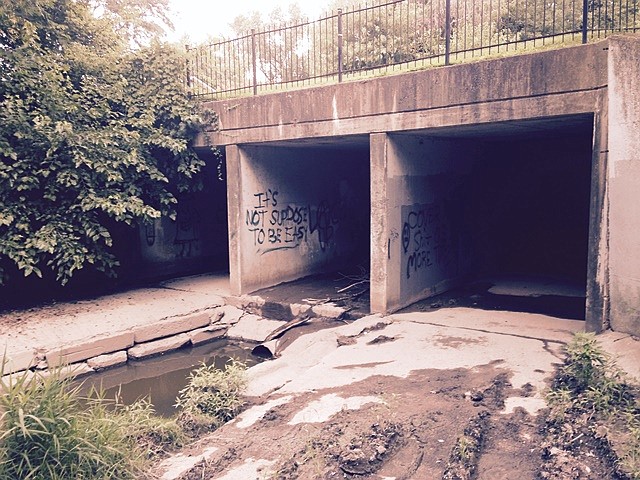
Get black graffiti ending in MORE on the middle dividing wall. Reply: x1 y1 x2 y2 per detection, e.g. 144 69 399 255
402 204 453 278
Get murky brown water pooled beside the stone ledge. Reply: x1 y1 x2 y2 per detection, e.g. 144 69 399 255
83 340 259 417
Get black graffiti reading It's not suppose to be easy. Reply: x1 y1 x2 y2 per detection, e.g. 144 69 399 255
245 189 338 251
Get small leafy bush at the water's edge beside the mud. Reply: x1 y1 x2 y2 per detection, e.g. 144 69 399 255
176 359 247 428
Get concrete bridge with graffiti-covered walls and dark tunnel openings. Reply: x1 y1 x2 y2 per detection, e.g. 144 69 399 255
195 36 640 335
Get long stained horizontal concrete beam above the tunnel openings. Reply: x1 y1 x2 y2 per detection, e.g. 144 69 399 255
200 41 608 145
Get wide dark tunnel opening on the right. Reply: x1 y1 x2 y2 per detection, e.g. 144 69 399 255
400 115 593 320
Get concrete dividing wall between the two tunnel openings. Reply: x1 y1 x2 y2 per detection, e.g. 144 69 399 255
370 133 473 313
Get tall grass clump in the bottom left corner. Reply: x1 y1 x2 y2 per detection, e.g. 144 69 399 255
0 369 141 480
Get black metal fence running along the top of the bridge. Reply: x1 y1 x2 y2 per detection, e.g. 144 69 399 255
187 0 640 99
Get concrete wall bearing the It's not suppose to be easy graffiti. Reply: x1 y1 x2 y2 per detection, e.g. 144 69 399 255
227 146 370 293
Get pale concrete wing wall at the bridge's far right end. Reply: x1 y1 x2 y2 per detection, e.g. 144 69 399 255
608 36 640 335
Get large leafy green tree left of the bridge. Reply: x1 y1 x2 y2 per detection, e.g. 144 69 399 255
0 0 215 284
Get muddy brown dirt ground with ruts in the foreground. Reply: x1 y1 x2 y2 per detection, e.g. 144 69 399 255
165 365 622 480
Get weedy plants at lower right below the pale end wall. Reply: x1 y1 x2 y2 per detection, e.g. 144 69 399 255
543 334 640 480
